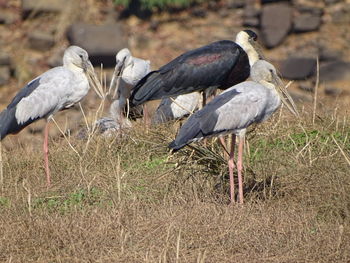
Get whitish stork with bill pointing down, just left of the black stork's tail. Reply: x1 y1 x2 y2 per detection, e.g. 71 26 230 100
109 48 151 124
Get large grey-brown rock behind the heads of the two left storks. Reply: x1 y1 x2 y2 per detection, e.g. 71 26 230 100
67 23 127 67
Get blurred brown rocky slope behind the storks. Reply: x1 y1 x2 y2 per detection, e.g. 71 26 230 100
0 0 350 148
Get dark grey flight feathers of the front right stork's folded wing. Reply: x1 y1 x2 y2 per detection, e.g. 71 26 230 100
169 89 239 151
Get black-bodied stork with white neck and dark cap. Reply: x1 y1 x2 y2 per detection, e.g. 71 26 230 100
130 30 259 106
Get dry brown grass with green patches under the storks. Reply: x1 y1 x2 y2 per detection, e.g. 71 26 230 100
0 106 350 262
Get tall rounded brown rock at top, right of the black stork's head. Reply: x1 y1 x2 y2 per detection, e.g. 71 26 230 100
261 2 292 48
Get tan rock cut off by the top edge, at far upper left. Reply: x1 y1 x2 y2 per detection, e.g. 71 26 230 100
22 0 67 18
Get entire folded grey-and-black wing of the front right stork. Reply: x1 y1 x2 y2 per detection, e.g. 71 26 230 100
169 81 266 150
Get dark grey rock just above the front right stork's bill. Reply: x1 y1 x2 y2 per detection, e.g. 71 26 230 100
281 57 316 80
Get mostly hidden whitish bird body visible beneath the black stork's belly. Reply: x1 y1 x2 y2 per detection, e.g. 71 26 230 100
152 92 201 124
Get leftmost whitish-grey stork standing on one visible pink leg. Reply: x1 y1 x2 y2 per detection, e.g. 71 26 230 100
0 46 101 187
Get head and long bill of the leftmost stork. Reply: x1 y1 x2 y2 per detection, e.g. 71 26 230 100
63 46 103 98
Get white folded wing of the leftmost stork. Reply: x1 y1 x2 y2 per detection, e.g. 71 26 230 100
13 67 75 124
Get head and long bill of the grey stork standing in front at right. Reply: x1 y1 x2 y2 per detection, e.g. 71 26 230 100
250 60 299 117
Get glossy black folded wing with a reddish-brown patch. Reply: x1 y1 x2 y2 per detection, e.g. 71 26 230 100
130 40 249 105
